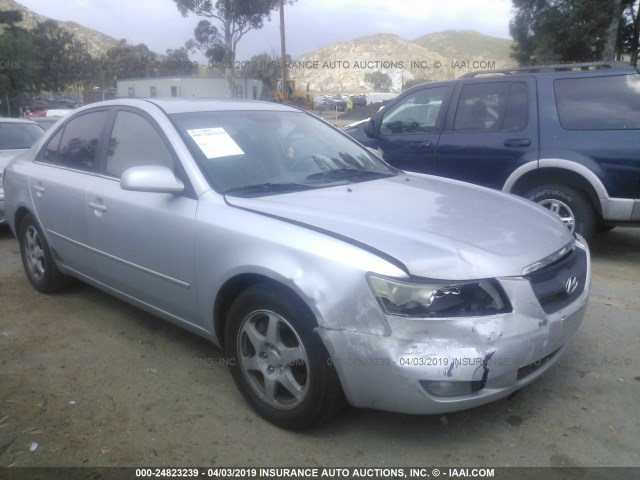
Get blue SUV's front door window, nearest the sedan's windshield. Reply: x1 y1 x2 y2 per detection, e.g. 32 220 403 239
380 87 448 135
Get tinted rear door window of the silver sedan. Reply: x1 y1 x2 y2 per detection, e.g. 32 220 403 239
42 111 109 171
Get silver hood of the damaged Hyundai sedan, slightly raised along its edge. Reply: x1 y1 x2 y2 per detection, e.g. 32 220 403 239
226 175 571 280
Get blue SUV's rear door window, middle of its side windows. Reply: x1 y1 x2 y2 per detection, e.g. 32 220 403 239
453 82 529 131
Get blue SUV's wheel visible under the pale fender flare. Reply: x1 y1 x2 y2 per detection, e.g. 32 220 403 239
525 184 596 241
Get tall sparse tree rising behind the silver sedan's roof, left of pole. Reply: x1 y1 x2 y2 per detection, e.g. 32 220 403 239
173 0 279 97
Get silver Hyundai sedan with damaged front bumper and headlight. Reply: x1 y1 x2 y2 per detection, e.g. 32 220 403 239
5 99 590 429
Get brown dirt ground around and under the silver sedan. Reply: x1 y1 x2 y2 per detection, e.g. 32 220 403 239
0 227 640 468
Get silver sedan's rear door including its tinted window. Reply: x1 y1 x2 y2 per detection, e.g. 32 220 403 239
29 109 110 277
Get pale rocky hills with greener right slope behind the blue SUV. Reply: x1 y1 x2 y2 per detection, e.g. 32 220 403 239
290 30 514 93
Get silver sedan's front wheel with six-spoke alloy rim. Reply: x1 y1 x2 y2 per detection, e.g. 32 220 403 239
225 284 344 430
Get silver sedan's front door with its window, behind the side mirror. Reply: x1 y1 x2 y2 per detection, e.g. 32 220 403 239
85 109 198 320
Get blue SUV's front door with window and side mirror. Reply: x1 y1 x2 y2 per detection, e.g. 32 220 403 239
372 86 451 173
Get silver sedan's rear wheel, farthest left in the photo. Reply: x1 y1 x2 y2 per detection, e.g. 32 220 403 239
18 214 68 293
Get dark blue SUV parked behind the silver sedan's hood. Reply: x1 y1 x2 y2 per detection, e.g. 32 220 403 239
344 63 640 239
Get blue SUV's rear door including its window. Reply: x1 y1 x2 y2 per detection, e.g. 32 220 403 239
434 77 539 189
